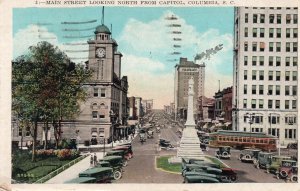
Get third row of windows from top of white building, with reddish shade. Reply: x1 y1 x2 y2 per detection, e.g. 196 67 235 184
244 42 298 52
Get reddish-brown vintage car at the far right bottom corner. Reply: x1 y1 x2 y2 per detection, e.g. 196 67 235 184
276 160 298 180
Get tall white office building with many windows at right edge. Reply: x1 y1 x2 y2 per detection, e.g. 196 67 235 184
233 7 298 145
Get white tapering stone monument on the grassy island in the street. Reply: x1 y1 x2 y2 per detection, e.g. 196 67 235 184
177 77 204 159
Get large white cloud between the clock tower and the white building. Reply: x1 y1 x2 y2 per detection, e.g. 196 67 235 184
118 11 233 108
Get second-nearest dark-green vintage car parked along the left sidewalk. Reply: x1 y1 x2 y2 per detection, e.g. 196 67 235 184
79 167 113 183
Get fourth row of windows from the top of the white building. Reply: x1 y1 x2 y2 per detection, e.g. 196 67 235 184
244 56 298 66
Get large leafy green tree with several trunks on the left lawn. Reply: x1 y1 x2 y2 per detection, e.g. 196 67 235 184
12 41 91 161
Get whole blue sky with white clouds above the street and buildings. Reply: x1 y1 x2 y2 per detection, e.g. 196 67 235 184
13 7 233 109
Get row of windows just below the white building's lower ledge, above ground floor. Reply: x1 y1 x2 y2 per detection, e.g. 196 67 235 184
244 114 297 125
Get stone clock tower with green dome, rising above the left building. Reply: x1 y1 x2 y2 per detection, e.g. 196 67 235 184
88 23 117 82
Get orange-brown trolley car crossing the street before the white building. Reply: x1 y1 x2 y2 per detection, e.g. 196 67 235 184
209 130 278 152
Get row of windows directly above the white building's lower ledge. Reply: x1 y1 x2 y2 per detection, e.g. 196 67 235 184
243 99 297 109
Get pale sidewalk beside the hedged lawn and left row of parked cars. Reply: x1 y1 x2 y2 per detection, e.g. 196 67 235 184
45 134 137 184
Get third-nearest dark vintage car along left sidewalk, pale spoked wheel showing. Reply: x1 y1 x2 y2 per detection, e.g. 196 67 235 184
97 156 123 180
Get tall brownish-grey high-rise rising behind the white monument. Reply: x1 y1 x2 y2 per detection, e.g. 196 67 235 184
174 58 205 120
